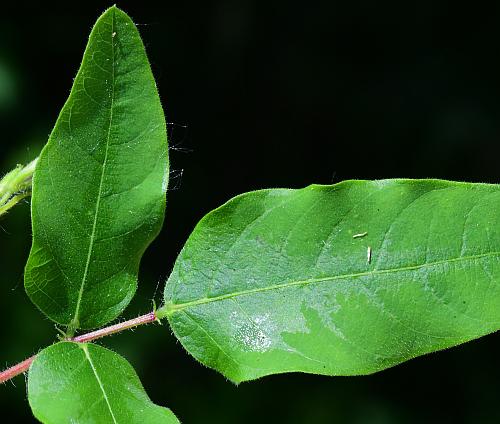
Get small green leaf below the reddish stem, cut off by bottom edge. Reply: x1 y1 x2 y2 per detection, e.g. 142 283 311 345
28 342 179 424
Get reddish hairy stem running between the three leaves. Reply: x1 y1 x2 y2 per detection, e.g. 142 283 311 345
0 311 158 384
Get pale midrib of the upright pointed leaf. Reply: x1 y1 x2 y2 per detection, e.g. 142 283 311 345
70 11 115 331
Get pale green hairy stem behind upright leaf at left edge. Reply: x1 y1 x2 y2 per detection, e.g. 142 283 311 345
0 158 38 216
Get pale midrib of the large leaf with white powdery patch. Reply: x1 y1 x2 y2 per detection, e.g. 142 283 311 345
166 248 500 318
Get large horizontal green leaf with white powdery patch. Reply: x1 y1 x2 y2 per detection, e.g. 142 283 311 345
158 180 500 382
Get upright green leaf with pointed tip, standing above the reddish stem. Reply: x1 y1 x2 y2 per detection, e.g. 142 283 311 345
25 7 168 331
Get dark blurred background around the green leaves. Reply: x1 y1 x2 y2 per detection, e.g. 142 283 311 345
0 0 500 423
